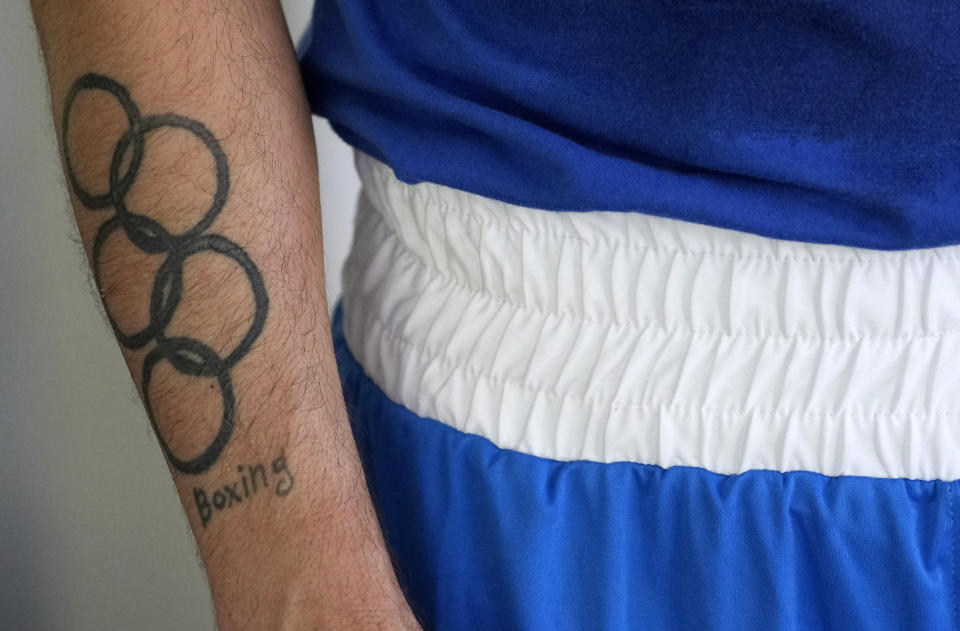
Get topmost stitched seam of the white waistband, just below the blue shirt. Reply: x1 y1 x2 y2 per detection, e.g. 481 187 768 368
358 158 960 264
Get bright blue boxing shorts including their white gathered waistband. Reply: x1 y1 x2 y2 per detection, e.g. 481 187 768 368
334 157 960 631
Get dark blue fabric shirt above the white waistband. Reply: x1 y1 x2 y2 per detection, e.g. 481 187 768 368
302 0 960 249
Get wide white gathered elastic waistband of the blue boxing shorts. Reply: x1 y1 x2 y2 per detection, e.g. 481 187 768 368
343 153 960 480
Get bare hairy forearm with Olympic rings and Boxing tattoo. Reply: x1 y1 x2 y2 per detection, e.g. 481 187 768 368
34 0 412 629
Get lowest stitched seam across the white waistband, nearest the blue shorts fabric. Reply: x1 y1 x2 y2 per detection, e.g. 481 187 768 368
345 297 960 420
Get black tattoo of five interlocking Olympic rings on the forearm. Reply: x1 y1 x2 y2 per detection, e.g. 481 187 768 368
62 74 268 474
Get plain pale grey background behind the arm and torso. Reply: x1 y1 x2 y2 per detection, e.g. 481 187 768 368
0 0 358 631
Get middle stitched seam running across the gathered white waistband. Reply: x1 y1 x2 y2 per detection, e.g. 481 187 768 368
368 210 960 344
